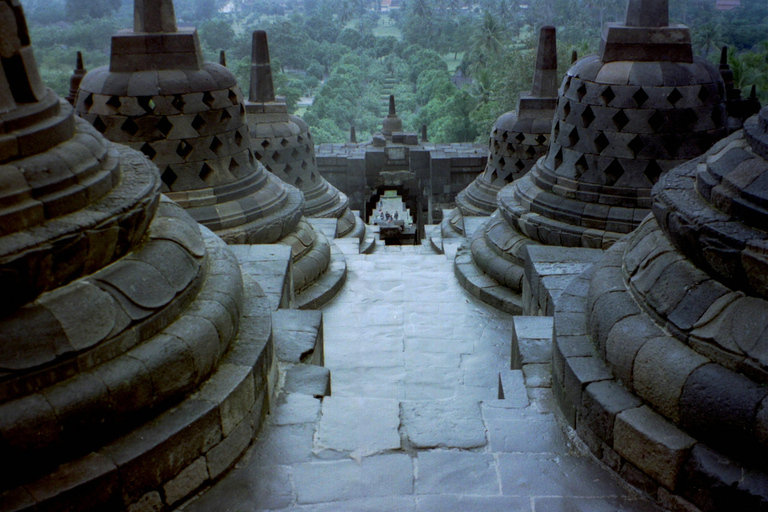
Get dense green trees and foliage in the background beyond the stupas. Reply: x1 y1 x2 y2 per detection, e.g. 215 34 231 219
24 0 768 142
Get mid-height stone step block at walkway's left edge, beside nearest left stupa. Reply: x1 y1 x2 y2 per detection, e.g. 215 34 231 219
272 309 325 366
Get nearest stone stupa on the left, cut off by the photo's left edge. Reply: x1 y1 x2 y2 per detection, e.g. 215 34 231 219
0 0 275 512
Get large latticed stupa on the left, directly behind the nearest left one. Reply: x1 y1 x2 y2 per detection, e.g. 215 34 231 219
76 0 340 302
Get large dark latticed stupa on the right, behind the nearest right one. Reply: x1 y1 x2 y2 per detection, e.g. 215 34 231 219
456 0 727 312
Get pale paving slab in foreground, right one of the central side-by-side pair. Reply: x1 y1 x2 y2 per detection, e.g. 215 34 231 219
400 399 487 449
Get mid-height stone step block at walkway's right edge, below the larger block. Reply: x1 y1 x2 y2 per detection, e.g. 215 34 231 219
511 316 553 388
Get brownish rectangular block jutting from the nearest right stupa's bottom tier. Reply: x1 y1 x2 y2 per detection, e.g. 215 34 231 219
613 406 696 489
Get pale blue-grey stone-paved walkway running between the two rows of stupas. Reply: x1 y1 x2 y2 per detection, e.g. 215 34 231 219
182 242 660 512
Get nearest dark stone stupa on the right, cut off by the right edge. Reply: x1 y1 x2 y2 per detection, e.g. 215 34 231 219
552 109 768 510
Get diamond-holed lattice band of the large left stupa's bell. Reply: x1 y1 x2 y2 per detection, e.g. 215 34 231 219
77 86 253 192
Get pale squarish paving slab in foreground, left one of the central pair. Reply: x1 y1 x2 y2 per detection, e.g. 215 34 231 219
315 396 400 456
